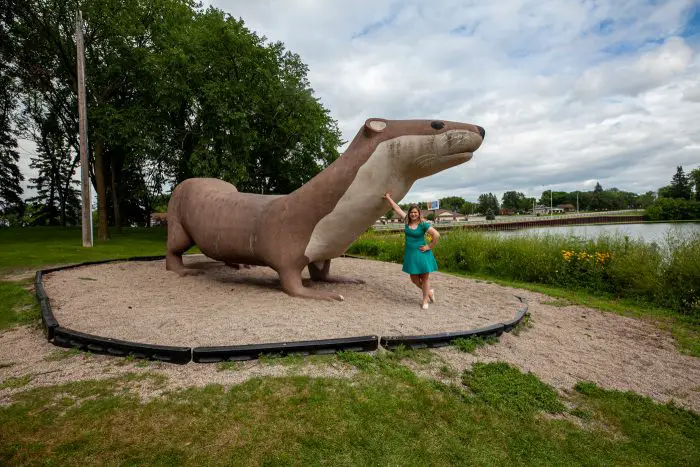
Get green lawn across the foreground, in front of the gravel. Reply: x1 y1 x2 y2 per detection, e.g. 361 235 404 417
0 360 700 466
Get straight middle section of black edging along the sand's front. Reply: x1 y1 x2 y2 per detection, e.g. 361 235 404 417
192 336 379 363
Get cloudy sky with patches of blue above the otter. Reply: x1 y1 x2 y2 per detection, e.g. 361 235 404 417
205 0 700 201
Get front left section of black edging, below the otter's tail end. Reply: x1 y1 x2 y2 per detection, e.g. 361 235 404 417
53 326 192 364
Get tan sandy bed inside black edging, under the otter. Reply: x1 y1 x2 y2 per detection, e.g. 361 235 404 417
43 255 522 347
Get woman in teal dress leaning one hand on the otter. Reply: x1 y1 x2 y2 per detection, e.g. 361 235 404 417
384 193 440 310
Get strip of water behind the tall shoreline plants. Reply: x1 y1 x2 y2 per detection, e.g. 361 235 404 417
489 222 700 244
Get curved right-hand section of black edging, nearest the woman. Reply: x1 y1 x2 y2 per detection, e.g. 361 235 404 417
379 297 527 350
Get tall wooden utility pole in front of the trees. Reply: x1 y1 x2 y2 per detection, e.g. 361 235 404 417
75 11 92 247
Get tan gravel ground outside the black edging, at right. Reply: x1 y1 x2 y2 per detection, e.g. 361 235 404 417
436 291 700 412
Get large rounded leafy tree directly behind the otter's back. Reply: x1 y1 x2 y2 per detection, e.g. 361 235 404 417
148 8 342 193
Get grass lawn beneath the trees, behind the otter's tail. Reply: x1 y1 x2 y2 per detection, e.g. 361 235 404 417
0 227 199 276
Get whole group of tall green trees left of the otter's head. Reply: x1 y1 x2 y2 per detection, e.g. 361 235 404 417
0 0 343 234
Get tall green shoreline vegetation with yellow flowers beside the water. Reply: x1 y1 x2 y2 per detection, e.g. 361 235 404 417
348 230 700 321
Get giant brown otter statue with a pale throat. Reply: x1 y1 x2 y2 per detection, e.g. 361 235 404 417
166 118 485 300
